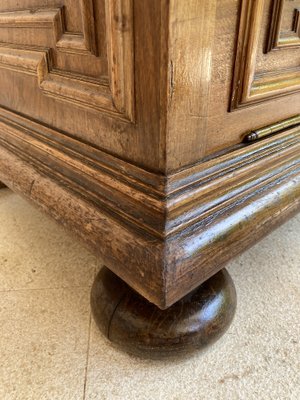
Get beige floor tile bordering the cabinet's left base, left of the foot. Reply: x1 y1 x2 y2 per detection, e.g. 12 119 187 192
0 189 100 291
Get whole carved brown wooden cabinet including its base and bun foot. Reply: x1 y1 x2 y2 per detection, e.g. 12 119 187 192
0 0 300 355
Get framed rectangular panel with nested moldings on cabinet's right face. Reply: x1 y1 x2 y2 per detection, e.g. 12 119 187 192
231 0 300 110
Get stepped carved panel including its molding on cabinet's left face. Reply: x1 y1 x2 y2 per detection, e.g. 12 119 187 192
0 0 133 120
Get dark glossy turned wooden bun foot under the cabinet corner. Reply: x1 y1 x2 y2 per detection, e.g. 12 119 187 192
91 268 236 358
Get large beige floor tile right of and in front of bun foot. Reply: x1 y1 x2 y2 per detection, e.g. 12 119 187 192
86 217 300 400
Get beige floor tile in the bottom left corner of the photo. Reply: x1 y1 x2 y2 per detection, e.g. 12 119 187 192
0 288 90 400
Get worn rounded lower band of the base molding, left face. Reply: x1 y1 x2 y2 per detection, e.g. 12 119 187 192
0 145 164 304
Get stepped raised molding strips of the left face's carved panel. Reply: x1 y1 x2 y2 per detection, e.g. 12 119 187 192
0 0 134 121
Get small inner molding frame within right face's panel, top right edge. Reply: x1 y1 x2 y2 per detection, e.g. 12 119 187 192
267 0 300 52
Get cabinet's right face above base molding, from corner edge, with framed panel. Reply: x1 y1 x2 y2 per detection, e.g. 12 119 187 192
168 0 300 169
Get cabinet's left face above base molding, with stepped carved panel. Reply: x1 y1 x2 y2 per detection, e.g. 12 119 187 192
0 0 164 167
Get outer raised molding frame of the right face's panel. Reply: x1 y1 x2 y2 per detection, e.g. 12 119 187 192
230 0 300 111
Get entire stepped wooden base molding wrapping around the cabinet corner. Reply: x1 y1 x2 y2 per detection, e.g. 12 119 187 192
0 109 300 309
